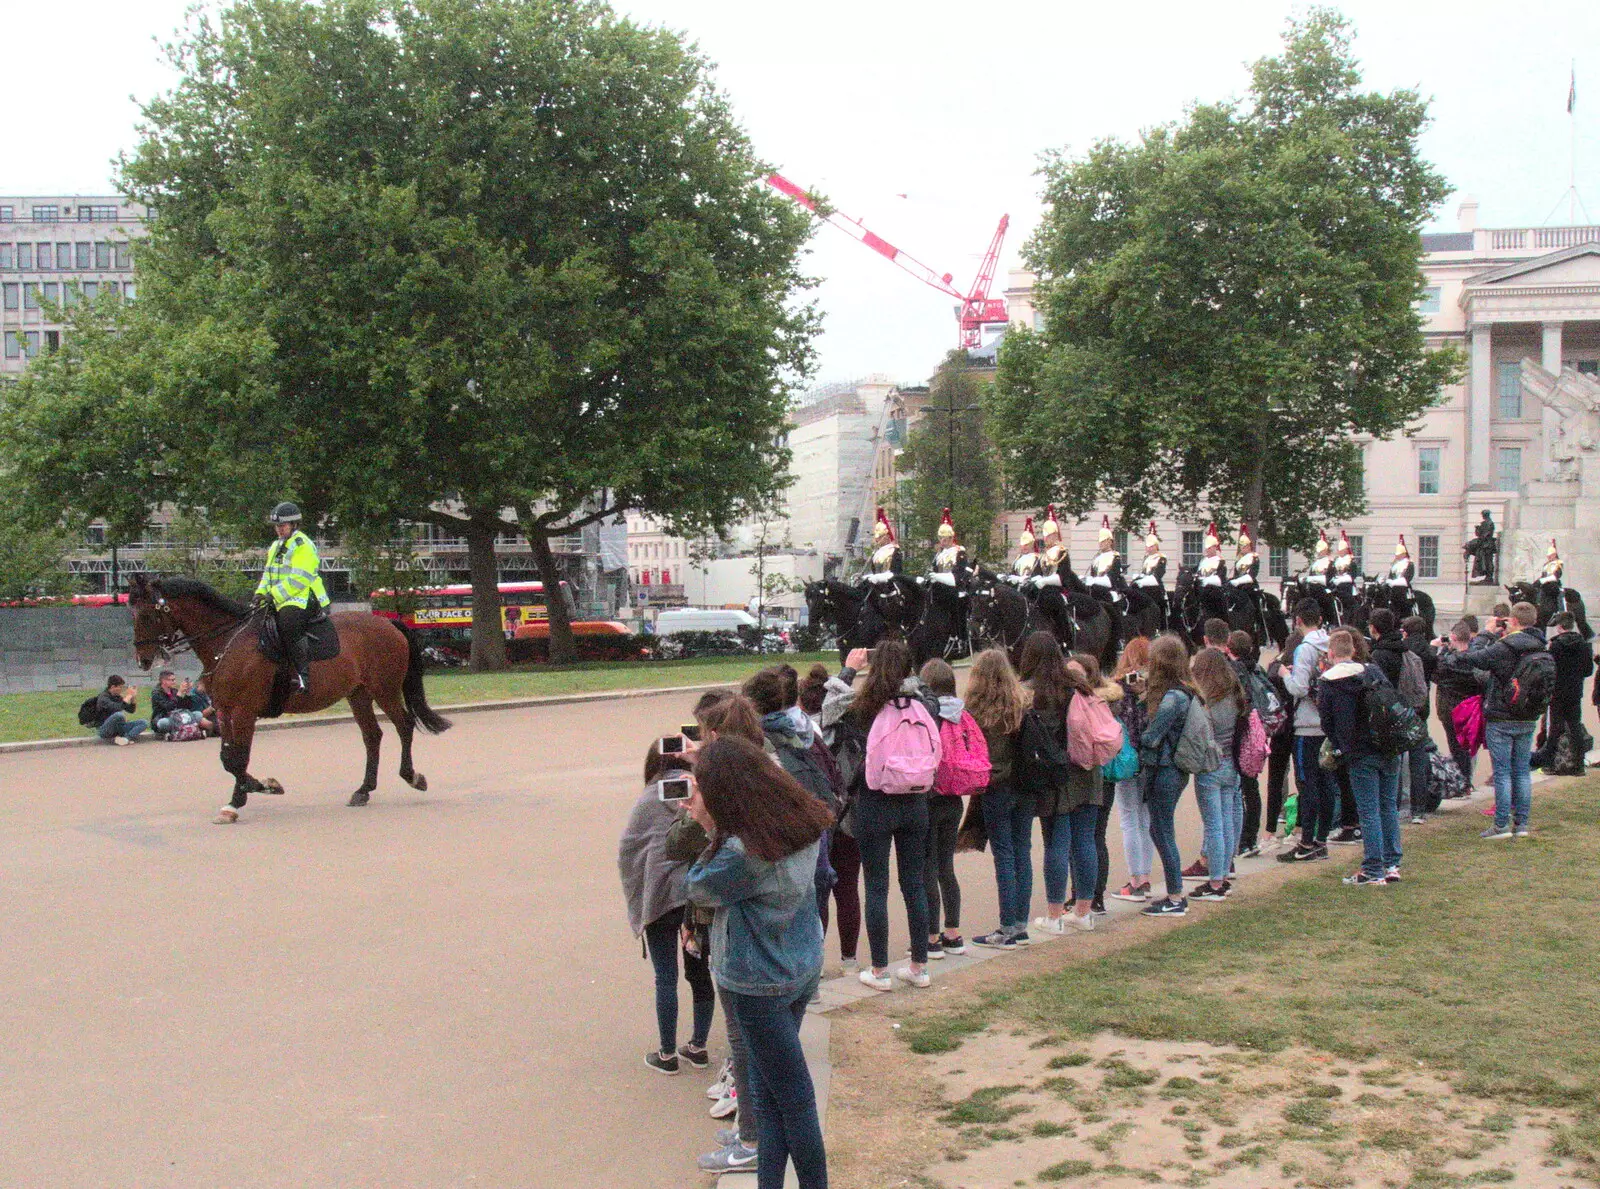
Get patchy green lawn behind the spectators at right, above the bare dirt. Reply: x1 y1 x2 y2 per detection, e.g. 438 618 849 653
901 776 1600 1168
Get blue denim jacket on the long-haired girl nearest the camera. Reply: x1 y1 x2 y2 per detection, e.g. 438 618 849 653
683 837 822 995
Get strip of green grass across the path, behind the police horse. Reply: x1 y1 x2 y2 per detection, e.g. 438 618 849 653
0 653 838 743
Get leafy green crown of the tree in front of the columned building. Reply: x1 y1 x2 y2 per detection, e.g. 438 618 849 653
990 10 1459 547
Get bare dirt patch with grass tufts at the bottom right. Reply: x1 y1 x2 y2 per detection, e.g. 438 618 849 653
830 1016 1594 1189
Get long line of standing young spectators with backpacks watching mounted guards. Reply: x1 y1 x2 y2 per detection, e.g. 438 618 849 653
618 600 1594 1189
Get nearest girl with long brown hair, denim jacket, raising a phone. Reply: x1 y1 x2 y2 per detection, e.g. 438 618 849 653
685 736 834 1189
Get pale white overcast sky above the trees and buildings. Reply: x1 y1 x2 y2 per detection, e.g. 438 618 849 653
0 0 1600 390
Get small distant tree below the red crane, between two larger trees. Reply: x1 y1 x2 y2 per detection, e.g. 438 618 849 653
898 350 1005 568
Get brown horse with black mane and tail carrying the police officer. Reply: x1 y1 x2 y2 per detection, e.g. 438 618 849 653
128 574 450 826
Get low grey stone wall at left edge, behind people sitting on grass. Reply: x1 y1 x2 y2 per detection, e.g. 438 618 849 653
0 607 200 693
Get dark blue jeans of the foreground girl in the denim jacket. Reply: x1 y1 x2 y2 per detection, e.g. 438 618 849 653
723 979 825 1189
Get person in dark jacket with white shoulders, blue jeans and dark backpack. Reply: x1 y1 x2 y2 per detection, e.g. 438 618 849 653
1317 629 1400 887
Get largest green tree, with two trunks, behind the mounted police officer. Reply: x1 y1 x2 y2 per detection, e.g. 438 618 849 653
3 0 814 667
